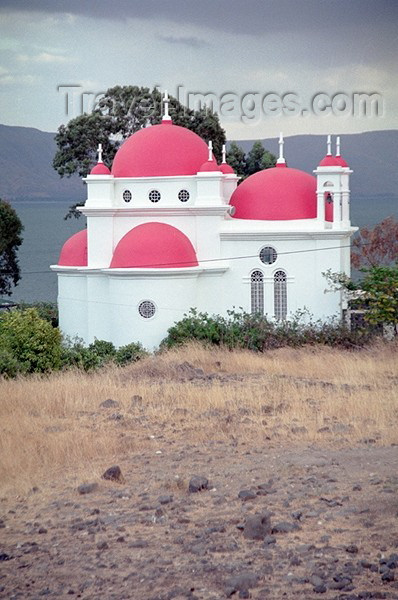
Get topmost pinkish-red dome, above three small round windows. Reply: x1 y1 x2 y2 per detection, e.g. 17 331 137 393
112 122 208 177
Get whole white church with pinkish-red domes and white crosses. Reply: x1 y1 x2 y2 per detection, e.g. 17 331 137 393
51 94 356 349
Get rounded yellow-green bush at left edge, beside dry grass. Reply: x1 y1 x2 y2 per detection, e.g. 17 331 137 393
0 308 61 373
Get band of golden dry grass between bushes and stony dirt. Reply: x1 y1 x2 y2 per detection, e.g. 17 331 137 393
0 344 398 493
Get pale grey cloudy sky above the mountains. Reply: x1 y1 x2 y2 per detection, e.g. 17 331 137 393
0 0 398 139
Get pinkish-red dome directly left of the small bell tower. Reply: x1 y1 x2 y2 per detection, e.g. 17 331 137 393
230 167 316 221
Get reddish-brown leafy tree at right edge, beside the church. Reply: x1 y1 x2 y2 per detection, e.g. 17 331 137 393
351 217 398 269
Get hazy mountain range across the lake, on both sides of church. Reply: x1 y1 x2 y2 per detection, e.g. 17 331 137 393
0 125 398 225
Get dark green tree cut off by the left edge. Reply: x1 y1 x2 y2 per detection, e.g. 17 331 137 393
0 199 23 296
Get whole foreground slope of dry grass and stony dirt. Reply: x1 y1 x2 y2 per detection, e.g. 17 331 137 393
0 349 398 600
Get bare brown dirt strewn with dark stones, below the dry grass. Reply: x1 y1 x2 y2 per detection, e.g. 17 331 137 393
0 439 398 600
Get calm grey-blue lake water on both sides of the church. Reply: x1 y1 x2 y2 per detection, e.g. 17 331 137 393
7 196 398 302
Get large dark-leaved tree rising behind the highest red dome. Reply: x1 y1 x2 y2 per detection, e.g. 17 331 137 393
53 86 225 177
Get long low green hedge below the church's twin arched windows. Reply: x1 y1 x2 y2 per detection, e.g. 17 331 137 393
161 309 374 352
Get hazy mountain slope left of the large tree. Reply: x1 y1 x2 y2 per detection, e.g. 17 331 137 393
0 125 85 202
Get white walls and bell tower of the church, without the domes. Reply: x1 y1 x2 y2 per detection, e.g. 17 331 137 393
52 127 355 349
